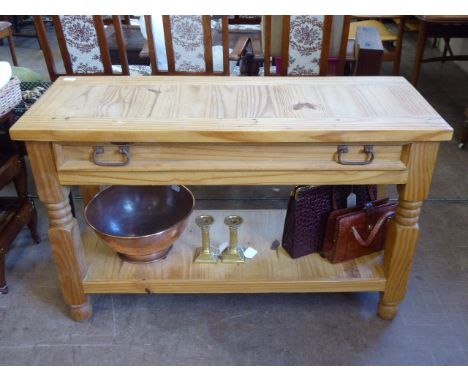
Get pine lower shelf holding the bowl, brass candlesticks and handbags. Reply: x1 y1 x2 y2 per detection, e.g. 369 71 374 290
82 210 386 293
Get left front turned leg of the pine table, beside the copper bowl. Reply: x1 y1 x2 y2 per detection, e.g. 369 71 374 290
26 142 91 321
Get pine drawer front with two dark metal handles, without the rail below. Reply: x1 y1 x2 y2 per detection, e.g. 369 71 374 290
55 143 406 172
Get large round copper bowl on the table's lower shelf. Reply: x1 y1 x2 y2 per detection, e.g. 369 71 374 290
84 186 195 263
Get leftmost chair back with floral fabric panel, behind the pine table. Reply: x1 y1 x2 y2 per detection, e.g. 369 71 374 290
34 15 128 81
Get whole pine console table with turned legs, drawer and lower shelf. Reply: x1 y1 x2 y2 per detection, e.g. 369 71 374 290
11 76 453 320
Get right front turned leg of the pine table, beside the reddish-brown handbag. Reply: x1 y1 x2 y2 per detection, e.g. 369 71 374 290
379 142 439 320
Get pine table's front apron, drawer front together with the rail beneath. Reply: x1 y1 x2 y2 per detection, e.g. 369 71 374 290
54 143 408 185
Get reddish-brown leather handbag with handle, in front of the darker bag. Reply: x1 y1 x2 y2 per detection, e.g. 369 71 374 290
320 198 397 263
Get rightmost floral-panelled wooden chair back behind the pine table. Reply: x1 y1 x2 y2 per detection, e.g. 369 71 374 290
264 15 333 76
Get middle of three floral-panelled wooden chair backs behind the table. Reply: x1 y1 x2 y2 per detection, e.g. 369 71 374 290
145 15 229 75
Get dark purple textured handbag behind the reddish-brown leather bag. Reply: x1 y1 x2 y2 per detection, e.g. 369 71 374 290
281 186 377 258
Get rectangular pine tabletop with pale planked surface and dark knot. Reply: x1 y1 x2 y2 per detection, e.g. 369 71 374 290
11 76 452 143
